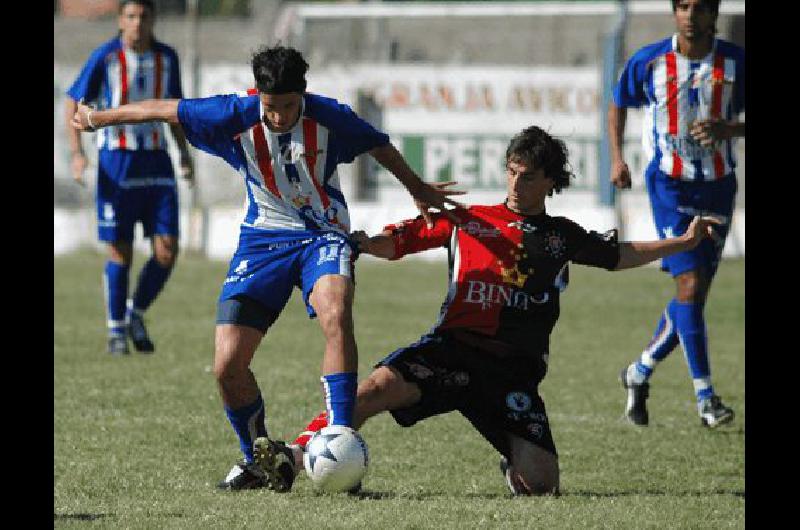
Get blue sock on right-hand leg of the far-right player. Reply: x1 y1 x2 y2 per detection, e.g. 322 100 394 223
675 302 714 401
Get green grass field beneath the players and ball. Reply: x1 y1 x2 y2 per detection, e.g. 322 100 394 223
53 252 745 529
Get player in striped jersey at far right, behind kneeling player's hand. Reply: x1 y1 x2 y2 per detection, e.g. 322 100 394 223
608 0 745 428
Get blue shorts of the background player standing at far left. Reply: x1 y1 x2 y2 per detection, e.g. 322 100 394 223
96 150 178 243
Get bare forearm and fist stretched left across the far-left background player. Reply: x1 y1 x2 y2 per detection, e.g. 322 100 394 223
71 99 180 132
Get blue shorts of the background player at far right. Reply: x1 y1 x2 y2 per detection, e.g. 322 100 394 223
645 170 737 279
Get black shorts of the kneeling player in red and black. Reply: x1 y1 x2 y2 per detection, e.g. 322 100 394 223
376 334 558 458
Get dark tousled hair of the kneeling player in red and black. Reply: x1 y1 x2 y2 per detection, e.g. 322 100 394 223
506 125 573 196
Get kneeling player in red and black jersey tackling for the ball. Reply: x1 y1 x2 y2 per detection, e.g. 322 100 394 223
278 127 718 494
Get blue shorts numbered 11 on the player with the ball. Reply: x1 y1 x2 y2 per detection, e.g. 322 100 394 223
219 226 356 318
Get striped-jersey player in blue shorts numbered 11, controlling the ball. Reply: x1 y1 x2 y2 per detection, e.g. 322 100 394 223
72 46 466 491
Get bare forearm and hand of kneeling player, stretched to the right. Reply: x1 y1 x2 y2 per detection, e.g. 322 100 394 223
614 216 722 271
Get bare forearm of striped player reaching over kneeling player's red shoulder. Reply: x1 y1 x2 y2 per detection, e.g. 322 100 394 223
369 144 465 227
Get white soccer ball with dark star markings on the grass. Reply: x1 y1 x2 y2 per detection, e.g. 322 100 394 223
303 425 369 492
